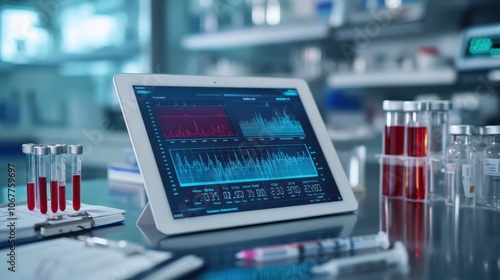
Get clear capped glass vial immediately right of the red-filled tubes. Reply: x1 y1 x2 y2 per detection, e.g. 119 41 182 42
446 125 477 207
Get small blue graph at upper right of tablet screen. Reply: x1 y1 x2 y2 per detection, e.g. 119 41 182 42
233 102 304 137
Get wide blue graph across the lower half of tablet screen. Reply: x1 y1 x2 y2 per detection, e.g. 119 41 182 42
170 145 318 187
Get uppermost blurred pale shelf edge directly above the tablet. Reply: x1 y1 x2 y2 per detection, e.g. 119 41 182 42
181 21 330 50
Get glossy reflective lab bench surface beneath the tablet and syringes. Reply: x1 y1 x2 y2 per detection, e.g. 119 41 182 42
0 164 500 279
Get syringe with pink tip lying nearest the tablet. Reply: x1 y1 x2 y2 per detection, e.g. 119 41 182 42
235 231 389 261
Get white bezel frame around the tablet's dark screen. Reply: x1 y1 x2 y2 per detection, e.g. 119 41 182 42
113 74 358 235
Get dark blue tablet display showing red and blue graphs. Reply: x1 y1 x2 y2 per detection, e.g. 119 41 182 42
133 85 342 219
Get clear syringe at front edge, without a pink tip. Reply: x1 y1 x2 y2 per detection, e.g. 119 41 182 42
311 241 408 276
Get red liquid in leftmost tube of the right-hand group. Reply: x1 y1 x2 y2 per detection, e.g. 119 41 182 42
382 126 405 197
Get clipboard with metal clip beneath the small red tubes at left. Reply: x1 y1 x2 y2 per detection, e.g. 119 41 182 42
0 200 125 248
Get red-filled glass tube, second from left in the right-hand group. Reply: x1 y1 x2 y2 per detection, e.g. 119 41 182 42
403 101 429 201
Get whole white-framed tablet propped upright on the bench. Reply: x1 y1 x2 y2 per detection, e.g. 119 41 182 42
114 74 358 235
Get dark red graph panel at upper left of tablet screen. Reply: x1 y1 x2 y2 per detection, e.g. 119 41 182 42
156 107 234 139
